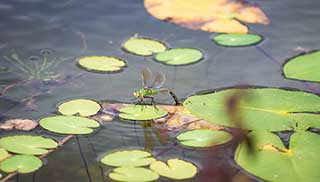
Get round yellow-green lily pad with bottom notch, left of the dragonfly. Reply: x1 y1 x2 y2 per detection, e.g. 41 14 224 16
58 99 101 116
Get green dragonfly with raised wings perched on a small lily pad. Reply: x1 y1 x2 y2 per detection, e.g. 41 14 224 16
133 67 179 106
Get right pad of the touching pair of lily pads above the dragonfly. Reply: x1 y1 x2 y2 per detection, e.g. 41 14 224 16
155 48 203 66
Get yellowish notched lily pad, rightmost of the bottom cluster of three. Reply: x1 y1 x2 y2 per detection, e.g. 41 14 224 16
150 159 197 179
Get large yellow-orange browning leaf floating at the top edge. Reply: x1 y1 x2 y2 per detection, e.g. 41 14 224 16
144 0 269 33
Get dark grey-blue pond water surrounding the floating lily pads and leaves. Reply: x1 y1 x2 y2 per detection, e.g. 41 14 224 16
0 0 320 182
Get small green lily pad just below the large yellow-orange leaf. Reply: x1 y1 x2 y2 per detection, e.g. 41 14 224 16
212 34 263 47
